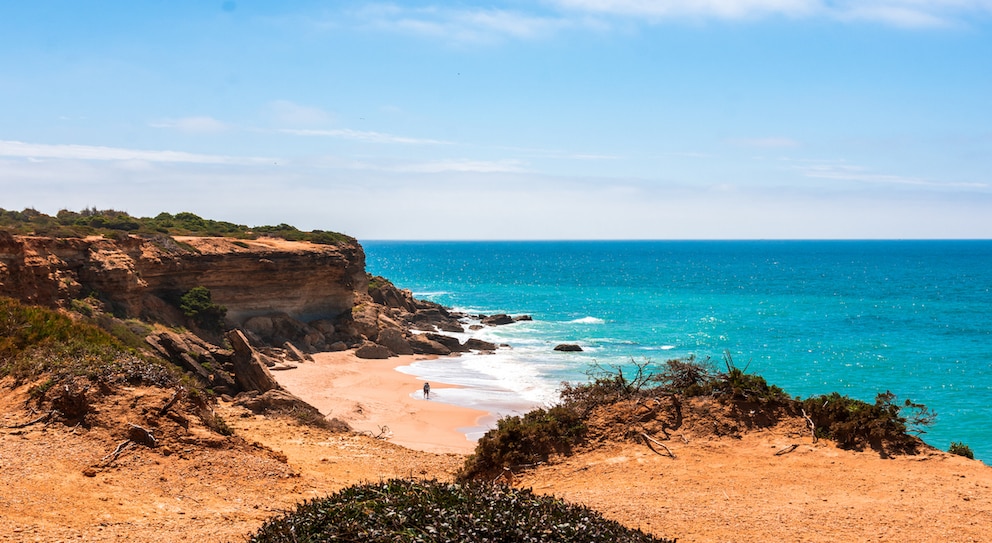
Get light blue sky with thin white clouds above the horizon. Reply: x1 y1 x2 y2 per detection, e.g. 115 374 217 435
0 0 992 240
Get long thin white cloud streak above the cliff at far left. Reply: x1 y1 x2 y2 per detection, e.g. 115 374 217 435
0 140 273 164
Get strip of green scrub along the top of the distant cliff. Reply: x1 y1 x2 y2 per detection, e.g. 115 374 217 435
0 208 355 245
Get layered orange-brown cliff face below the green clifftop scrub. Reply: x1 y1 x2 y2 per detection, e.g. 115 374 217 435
0 232 368 326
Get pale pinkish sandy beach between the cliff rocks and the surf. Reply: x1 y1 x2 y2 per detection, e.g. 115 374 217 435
273 351 491 454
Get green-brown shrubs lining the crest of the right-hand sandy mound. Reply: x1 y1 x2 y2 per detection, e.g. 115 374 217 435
458 353 935 480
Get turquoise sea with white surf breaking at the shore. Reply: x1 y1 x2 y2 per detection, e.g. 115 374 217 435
362 240 992 464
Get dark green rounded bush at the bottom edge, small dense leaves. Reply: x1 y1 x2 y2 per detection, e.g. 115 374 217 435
249 479 673 543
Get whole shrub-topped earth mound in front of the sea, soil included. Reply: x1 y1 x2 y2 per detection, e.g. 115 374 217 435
458 354 935 481
